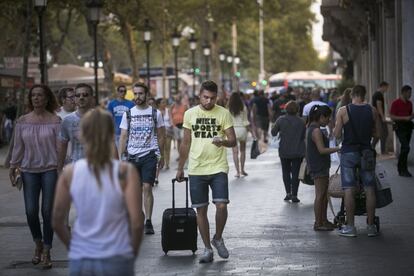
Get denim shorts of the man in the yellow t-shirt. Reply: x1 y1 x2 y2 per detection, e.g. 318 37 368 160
189 172 230 208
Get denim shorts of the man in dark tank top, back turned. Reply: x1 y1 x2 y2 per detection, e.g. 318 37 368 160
341 152 375 189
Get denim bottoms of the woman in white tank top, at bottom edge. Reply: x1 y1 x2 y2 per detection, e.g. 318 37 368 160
69 256 135 276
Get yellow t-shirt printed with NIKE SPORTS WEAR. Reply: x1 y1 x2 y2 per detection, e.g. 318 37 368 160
183 105 233 175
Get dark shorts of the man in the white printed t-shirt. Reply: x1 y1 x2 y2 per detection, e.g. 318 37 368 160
128 151 158 186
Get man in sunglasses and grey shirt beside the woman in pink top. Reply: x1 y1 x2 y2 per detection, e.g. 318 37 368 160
58 83 94 171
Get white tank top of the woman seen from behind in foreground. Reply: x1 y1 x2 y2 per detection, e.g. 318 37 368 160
69 159 133 259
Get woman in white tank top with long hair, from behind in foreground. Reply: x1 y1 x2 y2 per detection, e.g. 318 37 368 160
53 108 143 275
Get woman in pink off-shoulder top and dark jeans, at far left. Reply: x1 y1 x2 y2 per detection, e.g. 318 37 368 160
9 84 60 268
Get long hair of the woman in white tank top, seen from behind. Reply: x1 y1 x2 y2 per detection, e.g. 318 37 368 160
80 107 114 186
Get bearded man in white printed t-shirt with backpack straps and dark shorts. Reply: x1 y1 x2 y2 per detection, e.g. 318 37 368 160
118 82 165 235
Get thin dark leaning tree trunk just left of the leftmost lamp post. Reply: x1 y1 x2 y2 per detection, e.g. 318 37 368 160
17 0 33 117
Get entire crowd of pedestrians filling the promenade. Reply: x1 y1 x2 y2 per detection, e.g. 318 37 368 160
4 76 414 270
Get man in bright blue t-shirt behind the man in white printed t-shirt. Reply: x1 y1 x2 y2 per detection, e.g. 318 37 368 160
108 84 134 147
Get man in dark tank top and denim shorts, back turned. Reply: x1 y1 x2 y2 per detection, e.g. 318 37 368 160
334 85 380 237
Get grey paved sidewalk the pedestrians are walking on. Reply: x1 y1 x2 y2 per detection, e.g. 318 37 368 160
0 143 414 276
